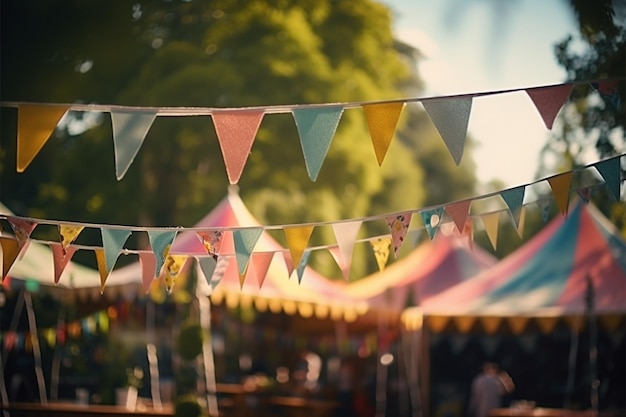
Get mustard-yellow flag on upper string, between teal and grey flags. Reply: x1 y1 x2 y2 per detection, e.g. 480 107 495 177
363 102 404 165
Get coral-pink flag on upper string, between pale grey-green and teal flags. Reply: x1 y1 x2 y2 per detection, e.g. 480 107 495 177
211 110 265 184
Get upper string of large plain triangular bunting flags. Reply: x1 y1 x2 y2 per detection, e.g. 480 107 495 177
0 79 619 184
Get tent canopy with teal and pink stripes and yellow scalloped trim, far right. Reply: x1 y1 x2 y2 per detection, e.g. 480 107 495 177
404 202 626 333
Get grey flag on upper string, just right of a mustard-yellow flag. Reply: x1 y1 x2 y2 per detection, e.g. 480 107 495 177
422 96 472 165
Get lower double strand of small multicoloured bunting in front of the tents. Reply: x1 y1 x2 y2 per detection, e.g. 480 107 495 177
0 154 626 291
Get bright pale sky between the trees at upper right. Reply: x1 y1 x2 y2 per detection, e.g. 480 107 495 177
383 0 578 187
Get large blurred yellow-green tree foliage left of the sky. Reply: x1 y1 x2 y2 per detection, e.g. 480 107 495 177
0 0 478 280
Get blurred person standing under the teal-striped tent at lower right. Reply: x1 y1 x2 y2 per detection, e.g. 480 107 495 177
469 362 515 417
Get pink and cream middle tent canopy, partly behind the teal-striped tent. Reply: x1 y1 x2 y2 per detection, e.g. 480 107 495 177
338 233 497 316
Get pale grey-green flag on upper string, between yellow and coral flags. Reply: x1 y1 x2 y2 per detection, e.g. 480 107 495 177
111 110 157 181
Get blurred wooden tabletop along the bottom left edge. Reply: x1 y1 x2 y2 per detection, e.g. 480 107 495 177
0 402 174 417
